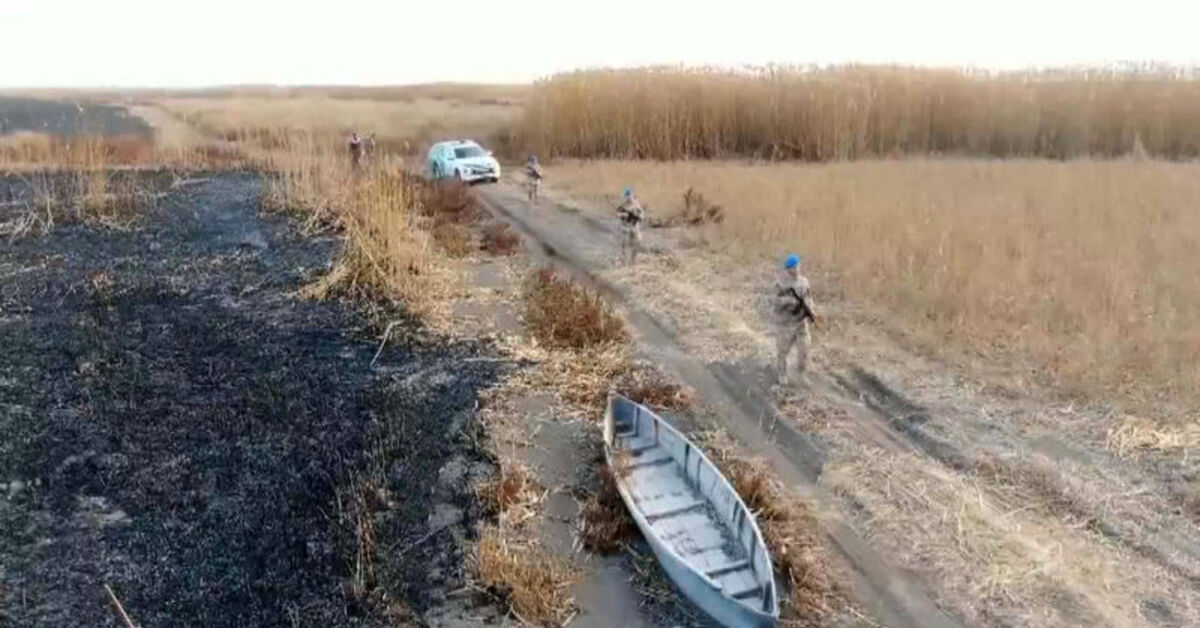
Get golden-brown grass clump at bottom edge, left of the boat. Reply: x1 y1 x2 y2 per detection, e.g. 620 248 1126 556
474 526 578 626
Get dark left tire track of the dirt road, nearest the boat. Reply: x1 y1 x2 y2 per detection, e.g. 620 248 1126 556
479 189 962 628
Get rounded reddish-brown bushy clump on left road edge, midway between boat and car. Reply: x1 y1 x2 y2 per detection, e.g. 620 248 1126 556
524 268 630 349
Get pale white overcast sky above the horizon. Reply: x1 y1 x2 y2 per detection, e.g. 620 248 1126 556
0 0 1200 88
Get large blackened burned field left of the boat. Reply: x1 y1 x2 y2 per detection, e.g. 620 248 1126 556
0 174 496 627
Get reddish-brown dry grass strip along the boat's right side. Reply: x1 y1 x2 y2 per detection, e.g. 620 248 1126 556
701 432 840 627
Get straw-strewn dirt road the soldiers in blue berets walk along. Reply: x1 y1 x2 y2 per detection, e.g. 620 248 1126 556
481 177 1200 627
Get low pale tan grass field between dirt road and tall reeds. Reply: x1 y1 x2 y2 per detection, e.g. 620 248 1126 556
550 161 1200 413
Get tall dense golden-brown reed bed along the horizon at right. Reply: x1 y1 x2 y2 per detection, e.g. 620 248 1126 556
522 66 1200 161
